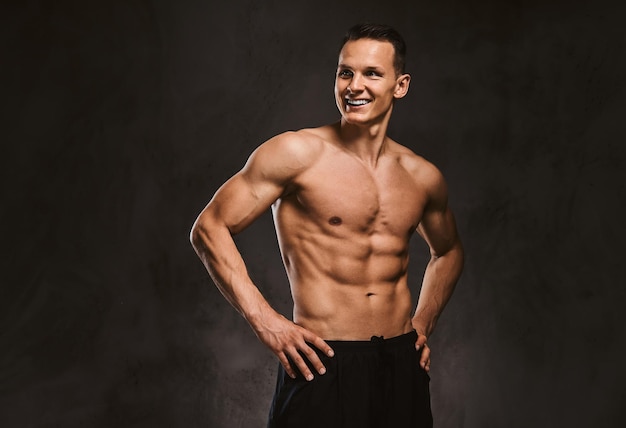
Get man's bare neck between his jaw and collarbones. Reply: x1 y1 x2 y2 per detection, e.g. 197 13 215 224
337 119 387 168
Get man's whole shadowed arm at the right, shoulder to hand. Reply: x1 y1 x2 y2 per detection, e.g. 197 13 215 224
411 171 463 371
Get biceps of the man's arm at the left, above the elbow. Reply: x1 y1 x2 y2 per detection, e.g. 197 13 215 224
203 173 282 234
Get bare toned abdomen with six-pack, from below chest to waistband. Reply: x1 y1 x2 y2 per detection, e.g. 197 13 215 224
277 219 412 340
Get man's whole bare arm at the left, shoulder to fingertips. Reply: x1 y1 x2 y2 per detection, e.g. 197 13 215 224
191 133 332 380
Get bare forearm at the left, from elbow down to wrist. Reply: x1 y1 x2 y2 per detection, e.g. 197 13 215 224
191 220 275 331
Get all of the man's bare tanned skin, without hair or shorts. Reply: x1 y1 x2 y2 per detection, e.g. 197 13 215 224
191 39 463 380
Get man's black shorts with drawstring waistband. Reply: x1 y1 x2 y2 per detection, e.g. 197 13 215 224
268 331 433 428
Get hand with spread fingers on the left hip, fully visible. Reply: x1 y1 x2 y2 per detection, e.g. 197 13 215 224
254 314 335 381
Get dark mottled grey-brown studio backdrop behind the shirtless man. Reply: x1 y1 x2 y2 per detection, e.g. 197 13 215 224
0 0 626 428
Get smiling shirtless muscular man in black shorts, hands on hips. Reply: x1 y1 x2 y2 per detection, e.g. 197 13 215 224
191 24 463 428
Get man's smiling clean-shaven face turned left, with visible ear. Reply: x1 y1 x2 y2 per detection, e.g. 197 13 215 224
335 39 410 125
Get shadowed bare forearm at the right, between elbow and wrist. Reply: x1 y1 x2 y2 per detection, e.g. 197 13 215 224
412 242 463 336
